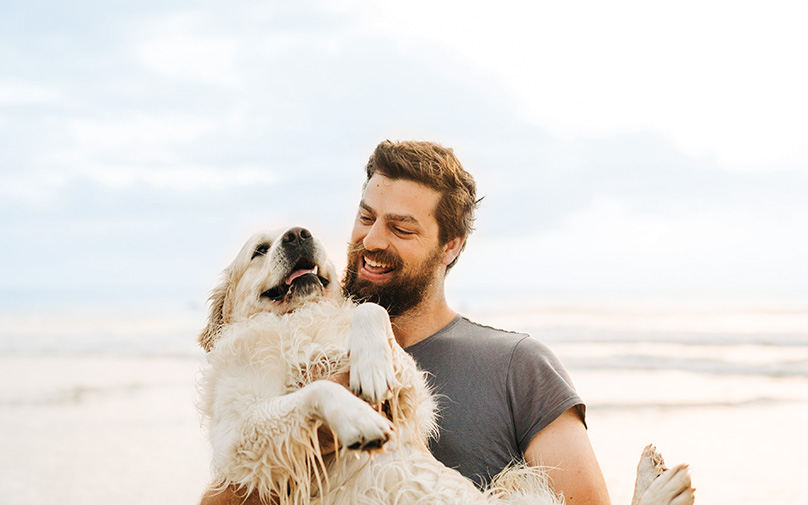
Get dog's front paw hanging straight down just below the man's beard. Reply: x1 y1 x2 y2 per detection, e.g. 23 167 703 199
348 303 396 405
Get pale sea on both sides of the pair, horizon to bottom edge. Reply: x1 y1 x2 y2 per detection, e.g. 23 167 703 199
0 301 808 505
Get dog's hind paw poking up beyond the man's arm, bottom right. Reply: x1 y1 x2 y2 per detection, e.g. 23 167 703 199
631 445 695 505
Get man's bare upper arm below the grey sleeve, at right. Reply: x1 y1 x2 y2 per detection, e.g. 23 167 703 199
525 407 610 505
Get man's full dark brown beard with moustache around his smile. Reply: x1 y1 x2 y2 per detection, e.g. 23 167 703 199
342 243 441 317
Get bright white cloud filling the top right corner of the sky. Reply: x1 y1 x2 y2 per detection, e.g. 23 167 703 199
364 0 808 171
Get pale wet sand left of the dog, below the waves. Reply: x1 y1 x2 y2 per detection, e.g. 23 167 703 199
0 356 208 505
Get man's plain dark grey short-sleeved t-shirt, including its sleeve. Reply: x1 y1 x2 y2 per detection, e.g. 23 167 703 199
405 316 585 486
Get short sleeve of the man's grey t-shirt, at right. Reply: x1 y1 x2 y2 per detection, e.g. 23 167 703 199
507 336 586 454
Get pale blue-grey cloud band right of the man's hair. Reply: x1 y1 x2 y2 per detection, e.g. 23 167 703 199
458 127 808 236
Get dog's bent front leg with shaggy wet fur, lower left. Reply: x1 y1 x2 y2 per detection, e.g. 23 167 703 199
219 380 393 504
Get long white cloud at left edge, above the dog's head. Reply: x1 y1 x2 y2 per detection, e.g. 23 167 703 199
0 111 278 200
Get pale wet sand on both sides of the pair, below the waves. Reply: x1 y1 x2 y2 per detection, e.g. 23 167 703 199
0 357 808 505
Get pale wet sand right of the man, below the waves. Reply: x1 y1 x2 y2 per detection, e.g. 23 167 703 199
574 372 808 505
